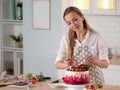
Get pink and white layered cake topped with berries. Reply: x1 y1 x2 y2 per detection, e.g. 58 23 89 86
62 64 89 84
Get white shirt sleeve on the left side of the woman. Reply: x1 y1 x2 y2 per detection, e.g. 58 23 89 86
55 34 68 63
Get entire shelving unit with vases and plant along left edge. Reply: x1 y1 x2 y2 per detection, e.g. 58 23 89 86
0 0 23 75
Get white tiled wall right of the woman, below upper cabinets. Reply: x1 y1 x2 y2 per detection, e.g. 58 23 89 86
86 15 120 55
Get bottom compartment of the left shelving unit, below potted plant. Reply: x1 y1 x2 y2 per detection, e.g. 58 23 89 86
2 48 23 75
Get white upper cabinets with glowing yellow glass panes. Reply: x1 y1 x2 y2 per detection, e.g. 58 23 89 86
62 0 120 15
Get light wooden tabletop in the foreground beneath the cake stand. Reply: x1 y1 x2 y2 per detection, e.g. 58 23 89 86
0 80 120 90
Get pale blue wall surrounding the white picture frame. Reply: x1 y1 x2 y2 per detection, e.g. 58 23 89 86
23 0 62 77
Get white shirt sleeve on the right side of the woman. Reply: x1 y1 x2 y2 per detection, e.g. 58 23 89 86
98 36 109 63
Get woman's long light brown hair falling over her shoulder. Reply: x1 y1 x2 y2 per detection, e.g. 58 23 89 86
63 6 94 58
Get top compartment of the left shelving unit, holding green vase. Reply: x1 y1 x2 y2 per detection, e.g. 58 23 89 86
1 0 22 20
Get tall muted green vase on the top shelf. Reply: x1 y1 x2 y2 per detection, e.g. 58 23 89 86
7 0 16 20
